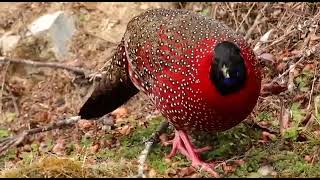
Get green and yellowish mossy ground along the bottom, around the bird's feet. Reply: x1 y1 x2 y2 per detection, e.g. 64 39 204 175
0 112 320 177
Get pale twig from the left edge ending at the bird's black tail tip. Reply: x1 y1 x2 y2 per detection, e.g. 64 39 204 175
0 116 81 154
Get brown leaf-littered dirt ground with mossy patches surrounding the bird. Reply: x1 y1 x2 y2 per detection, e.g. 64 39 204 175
0 2 320 177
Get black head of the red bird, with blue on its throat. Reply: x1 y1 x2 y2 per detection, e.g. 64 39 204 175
210 41 247 96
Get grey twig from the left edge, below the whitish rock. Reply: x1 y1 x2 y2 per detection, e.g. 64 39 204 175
0 57 91 77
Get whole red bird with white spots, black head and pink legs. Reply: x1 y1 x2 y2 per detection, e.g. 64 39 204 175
79 9 261 176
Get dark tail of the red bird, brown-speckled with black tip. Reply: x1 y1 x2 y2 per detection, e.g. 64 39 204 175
79 43 139 119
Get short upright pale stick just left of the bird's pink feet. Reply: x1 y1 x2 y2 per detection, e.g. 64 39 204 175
135 121 169 178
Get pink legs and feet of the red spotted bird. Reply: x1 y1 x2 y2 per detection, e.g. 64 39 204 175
168 130 219 177
